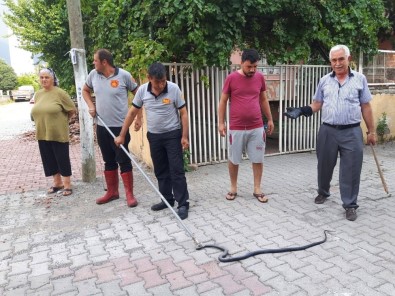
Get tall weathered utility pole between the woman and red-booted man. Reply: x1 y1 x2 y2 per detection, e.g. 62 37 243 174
67 0 96 182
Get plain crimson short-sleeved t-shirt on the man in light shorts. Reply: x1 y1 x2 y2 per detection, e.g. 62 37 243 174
222 71 266 130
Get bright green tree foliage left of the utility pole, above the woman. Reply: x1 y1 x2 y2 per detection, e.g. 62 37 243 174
4 0 89 91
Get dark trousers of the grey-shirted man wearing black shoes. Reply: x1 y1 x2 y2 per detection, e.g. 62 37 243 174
147 130 189 208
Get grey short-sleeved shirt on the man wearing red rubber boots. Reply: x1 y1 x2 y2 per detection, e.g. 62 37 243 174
86 68 138 127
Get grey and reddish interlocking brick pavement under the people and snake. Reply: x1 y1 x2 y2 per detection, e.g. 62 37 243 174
0 123 395 296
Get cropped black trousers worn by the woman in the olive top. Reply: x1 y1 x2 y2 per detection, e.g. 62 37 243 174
38 140 71 177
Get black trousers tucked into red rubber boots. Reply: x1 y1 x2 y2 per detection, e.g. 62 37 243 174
96 125 133 173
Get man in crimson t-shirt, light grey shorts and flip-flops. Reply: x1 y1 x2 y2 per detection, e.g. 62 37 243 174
218 49 274 202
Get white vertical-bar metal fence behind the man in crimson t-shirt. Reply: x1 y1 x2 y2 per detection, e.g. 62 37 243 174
165 63 330 165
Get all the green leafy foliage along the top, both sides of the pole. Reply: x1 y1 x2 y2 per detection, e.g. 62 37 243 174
5 0 392 92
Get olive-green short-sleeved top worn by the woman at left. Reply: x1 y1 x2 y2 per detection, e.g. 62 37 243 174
31 87 75 143
